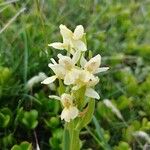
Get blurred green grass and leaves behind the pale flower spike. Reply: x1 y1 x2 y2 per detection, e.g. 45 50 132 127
0 0 150 150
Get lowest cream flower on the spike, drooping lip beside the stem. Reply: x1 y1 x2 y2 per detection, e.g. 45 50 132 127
49 93 79 122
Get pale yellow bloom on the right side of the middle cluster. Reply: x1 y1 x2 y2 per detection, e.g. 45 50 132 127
68 54 109 99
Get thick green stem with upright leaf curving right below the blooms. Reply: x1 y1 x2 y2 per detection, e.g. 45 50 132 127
63 99 95 150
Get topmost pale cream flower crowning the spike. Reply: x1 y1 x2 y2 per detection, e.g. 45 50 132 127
49 25 87 54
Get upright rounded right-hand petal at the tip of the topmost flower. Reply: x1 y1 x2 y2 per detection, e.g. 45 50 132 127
73 25 84 40
